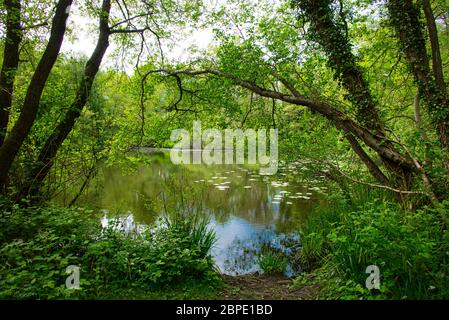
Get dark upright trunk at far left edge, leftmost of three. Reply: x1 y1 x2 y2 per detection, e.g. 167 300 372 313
0 0 22 147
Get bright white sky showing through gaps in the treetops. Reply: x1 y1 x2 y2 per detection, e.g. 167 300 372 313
61 0 276 74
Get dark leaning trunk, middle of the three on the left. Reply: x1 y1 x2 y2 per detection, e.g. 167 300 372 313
0 0 73 189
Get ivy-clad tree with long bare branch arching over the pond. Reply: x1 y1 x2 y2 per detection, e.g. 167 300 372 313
144 0 437 201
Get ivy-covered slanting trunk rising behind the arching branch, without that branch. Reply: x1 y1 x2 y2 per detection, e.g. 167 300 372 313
296 0 412 190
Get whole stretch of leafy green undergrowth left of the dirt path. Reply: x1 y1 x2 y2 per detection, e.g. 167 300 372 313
0 200 221 299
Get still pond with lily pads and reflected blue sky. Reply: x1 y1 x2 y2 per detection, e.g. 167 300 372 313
63 152 327 275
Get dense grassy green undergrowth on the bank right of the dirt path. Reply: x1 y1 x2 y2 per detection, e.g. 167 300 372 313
295 190 449 299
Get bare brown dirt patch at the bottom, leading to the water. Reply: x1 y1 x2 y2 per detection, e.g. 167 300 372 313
218 274 318 300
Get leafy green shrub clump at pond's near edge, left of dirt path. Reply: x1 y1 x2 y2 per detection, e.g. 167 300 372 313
85 219 215 289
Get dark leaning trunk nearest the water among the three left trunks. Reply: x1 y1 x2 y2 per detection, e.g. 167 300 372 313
19 0 111 197
